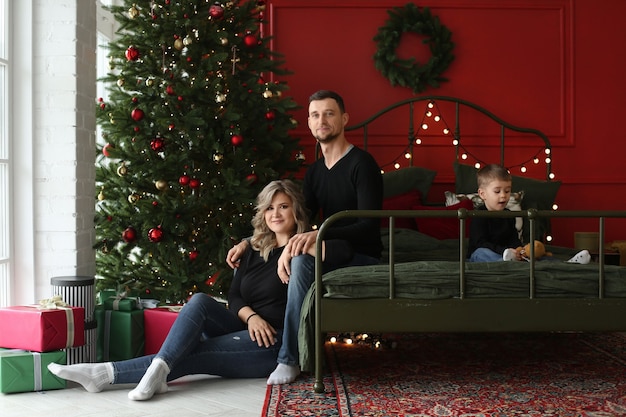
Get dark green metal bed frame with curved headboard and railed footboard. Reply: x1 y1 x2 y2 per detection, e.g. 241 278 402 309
314 96 626 393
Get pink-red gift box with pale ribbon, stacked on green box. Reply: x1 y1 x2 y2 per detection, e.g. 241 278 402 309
0 306 85 352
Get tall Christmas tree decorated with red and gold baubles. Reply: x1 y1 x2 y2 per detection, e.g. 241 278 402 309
95 0 304 302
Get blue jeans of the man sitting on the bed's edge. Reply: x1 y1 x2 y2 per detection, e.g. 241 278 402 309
277 253 380 366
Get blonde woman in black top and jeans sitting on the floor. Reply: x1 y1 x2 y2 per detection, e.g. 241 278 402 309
48 180 308 400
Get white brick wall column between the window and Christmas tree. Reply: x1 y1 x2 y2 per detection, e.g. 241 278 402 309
24 0 97 304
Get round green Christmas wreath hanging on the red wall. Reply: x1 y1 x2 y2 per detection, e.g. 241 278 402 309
374 3 454 93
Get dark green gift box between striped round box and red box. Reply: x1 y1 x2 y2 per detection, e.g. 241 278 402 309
96 305 145 362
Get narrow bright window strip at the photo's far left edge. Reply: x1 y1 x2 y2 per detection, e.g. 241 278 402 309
0 0 11 306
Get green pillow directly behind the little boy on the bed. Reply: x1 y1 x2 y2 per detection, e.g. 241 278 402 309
454 162 561 243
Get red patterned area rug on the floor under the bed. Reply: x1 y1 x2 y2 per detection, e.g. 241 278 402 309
262 333 626 417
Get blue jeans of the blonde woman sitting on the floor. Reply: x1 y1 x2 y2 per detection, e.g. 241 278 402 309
113 290 282 384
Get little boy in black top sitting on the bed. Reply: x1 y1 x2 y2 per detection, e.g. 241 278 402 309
468 164 591 264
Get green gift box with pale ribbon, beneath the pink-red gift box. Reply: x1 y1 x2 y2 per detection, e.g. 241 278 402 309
0 349 67 393
